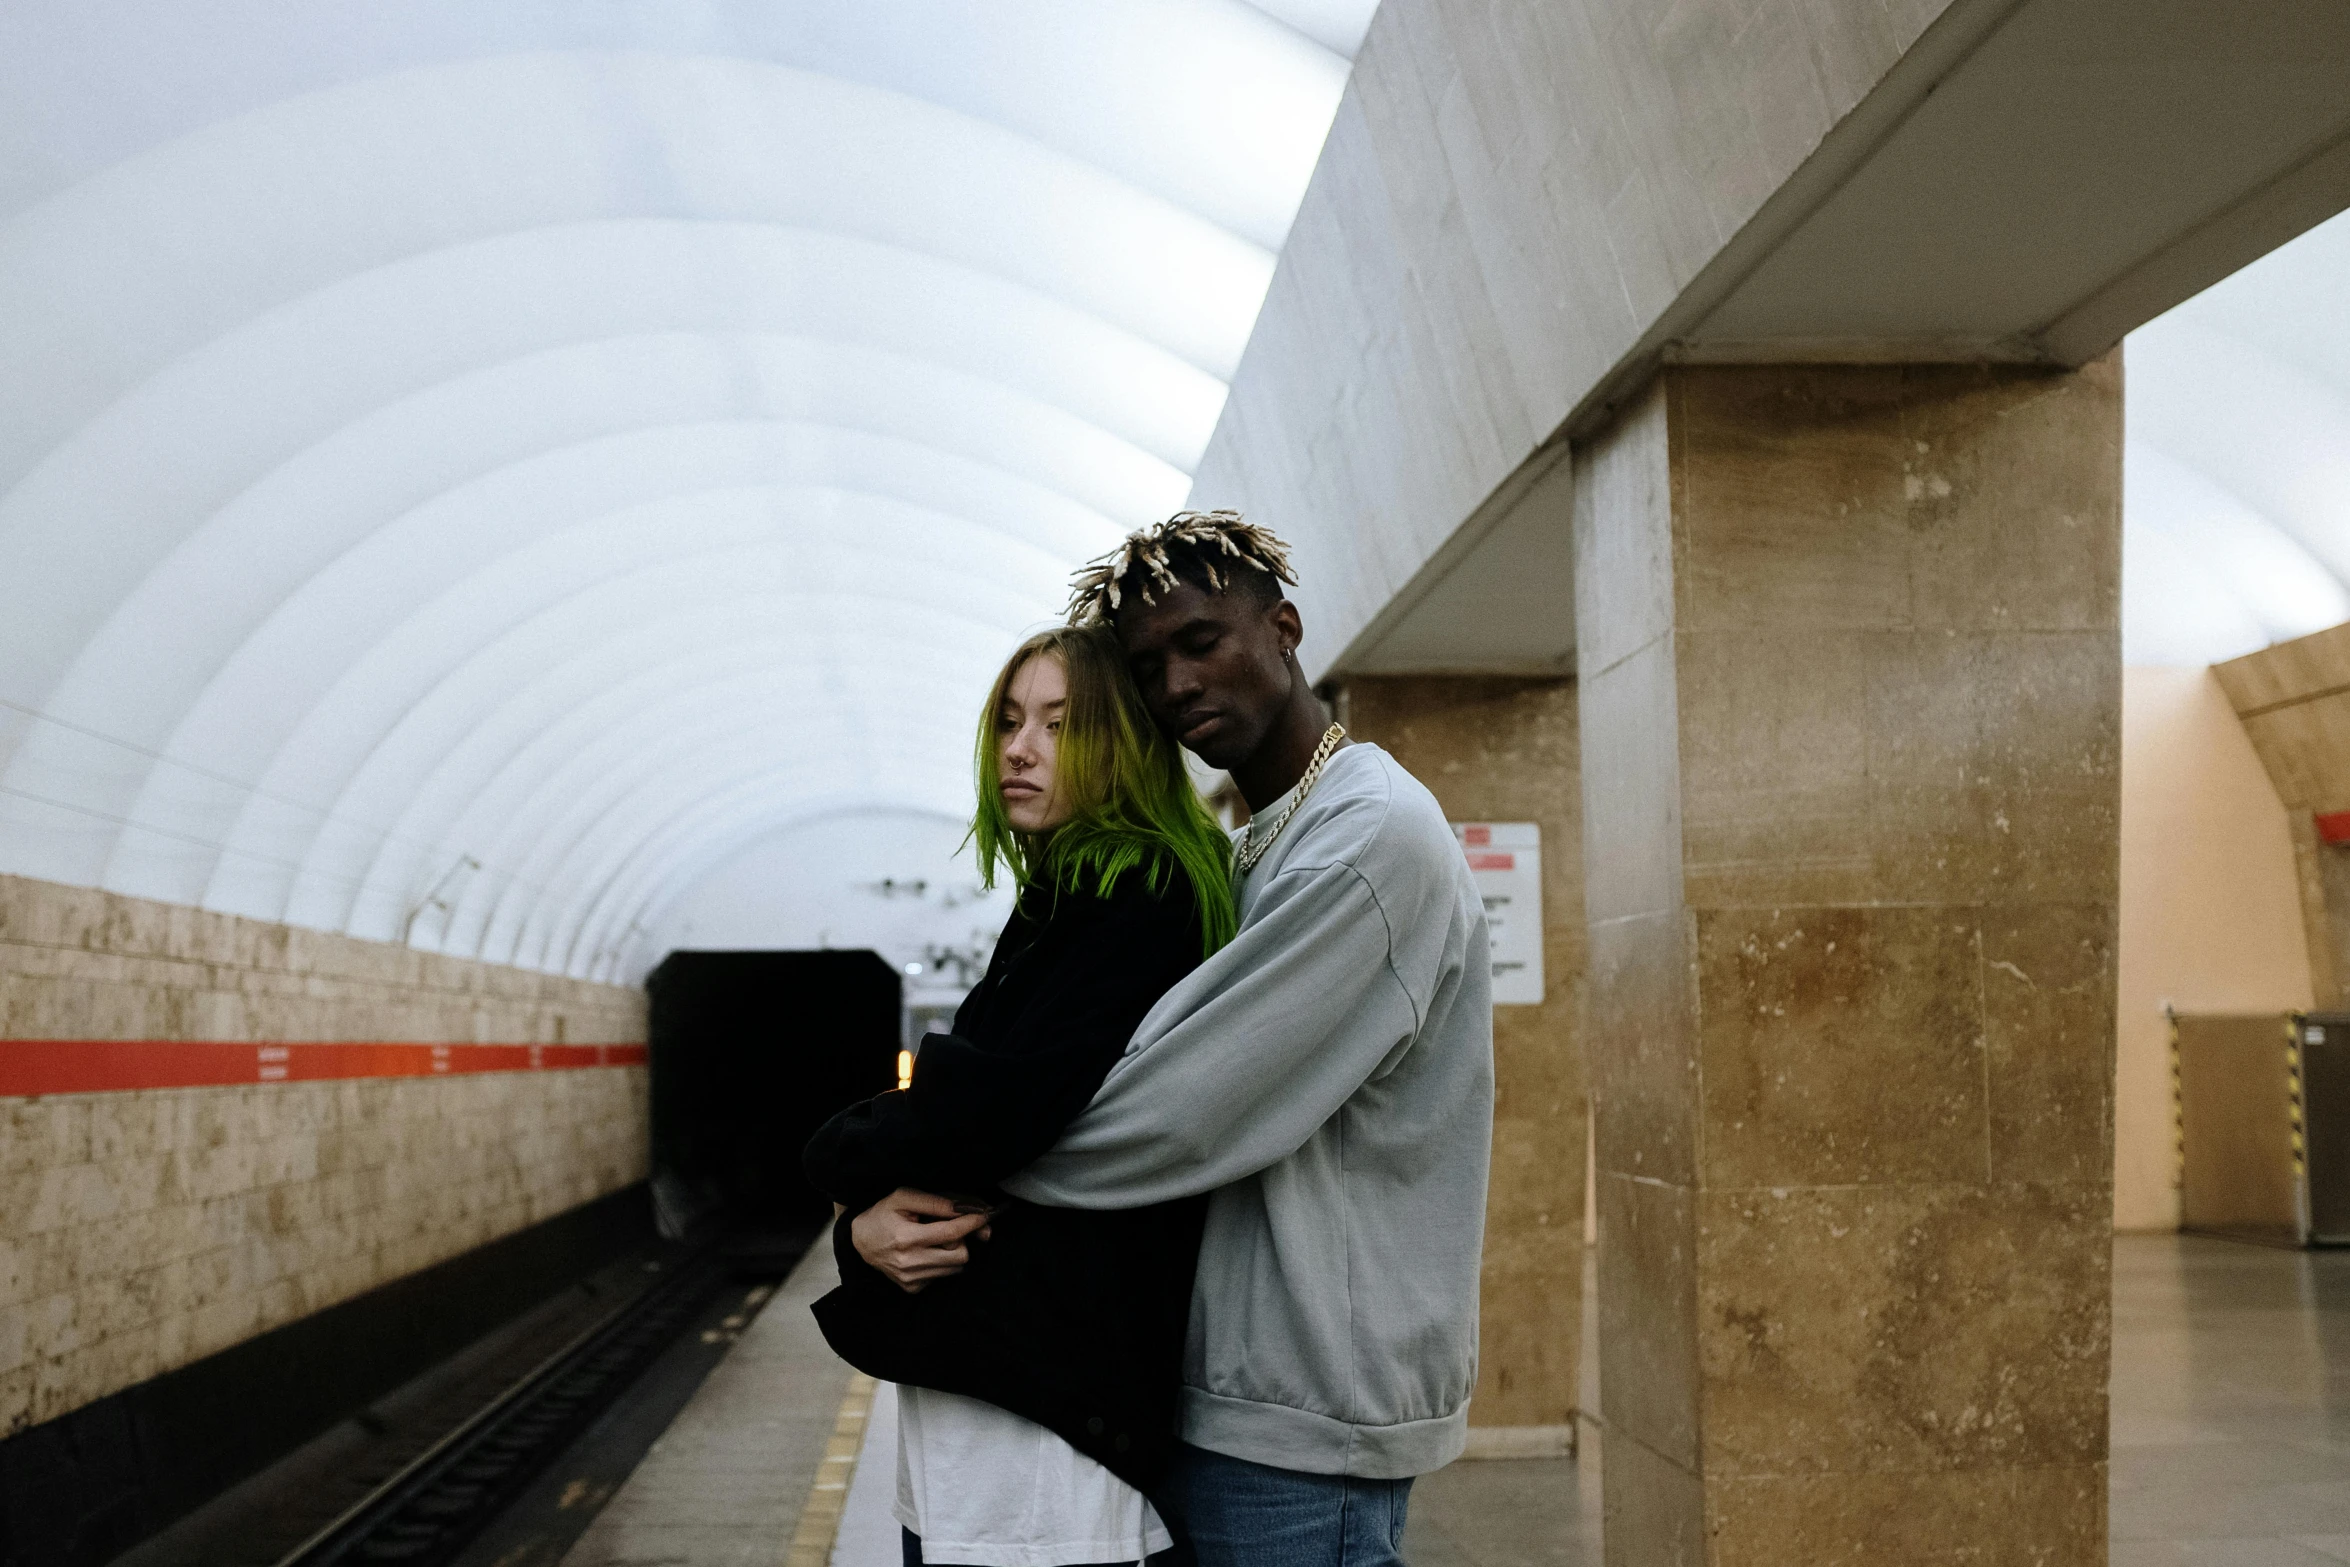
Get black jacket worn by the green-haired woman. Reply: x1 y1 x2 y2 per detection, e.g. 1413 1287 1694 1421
806 867 1206 1492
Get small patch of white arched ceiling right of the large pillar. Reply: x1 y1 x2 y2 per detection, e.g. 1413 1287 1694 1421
2122 214 2350 665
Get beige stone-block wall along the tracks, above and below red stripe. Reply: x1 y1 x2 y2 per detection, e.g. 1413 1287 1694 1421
0 876 646 1433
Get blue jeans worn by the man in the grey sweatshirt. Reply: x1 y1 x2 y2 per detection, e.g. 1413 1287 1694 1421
1166 1442 1412 1567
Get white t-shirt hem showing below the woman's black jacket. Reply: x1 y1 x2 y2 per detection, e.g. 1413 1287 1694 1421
893 1386 1175 1567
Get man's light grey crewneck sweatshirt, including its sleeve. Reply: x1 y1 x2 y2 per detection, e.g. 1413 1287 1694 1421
1006 745 1492 1480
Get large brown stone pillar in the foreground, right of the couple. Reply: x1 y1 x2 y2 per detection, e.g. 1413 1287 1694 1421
1575 357 2122 1567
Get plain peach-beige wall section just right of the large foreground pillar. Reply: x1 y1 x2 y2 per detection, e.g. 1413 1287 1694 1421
2113 667 2310 1231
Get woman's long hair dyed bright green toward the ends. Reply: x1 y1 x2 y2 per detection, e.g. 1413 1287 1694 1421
971 625 1238 951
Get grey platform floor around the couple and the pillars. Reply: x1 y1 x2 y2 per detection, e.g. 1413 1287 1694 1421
564 1236 2350 1567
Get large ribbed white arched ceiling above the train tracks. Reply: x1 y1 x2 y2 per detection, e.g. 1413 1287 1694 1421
0 0 1372 975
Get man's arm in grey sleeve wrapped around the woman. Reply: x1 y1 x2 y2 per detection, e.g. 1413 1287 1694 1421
1003 865 1419 1208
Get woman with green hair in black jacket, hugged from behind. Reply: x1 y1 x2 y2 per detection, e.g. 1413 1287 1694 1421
806 625 1236 1567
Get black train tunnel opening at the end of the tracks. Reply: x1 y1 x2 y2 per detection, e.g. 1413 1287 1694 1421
646 951 900 1236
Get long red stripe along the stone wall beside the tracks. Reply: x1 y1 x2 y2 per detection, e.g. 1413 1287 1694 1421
0 1038 646 1099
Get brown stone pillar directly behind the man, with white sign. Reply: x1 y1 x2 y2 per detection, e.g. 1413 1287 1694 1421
1344 677 1589 1457
